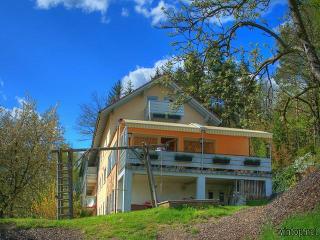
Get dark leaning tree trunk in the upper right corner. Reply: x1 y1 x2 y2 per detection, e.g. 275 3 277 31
288 0 320 83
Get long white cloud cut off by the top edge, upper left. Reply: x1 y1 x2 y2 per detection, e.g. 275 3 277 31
36 0 110 14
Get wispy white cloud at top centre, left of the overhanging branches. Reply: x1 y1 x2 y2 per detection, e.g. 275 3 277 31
135 0 174 25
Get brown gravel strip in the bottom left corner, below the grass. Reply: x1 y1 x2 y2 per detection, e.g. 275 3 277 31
0 225 84 240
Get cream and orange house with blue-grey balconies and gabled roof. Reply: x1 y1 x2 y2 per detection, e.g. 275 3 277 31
83 81 272 215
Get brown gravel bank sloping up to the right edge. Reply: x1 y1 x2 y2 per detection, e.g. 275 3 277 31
158 171 320 240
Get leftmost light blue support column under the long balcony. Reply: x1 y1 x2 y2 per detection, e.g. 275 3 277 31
121 169 133 212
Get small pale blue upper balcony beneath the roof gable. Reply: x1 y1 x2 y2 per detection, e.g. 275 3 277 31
145 100 184 120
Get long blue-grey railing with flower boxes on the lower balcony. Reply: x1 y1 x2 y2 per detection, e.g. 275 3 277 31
121 151 271 172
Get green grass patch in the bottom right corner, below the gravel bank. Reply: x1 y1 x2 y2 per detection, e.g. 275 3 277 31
261 206 320 240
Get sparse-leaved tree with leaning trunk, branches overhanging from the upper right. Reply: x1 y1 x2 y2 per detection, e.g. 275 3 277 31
162 0 320 84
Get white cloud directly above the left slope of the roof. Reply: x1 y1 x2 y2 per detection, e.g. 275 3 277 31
122 59 169 89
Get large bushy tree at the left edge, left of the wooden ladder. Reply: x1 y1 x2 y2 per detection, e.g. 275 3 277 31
0 99 63 216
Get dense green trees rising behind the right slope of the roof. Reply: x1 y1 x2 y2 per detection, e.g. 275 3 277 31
164 48 262 127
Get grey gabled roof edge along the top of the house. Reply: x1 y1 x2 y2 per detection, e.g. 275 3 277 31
91 79 221 150
